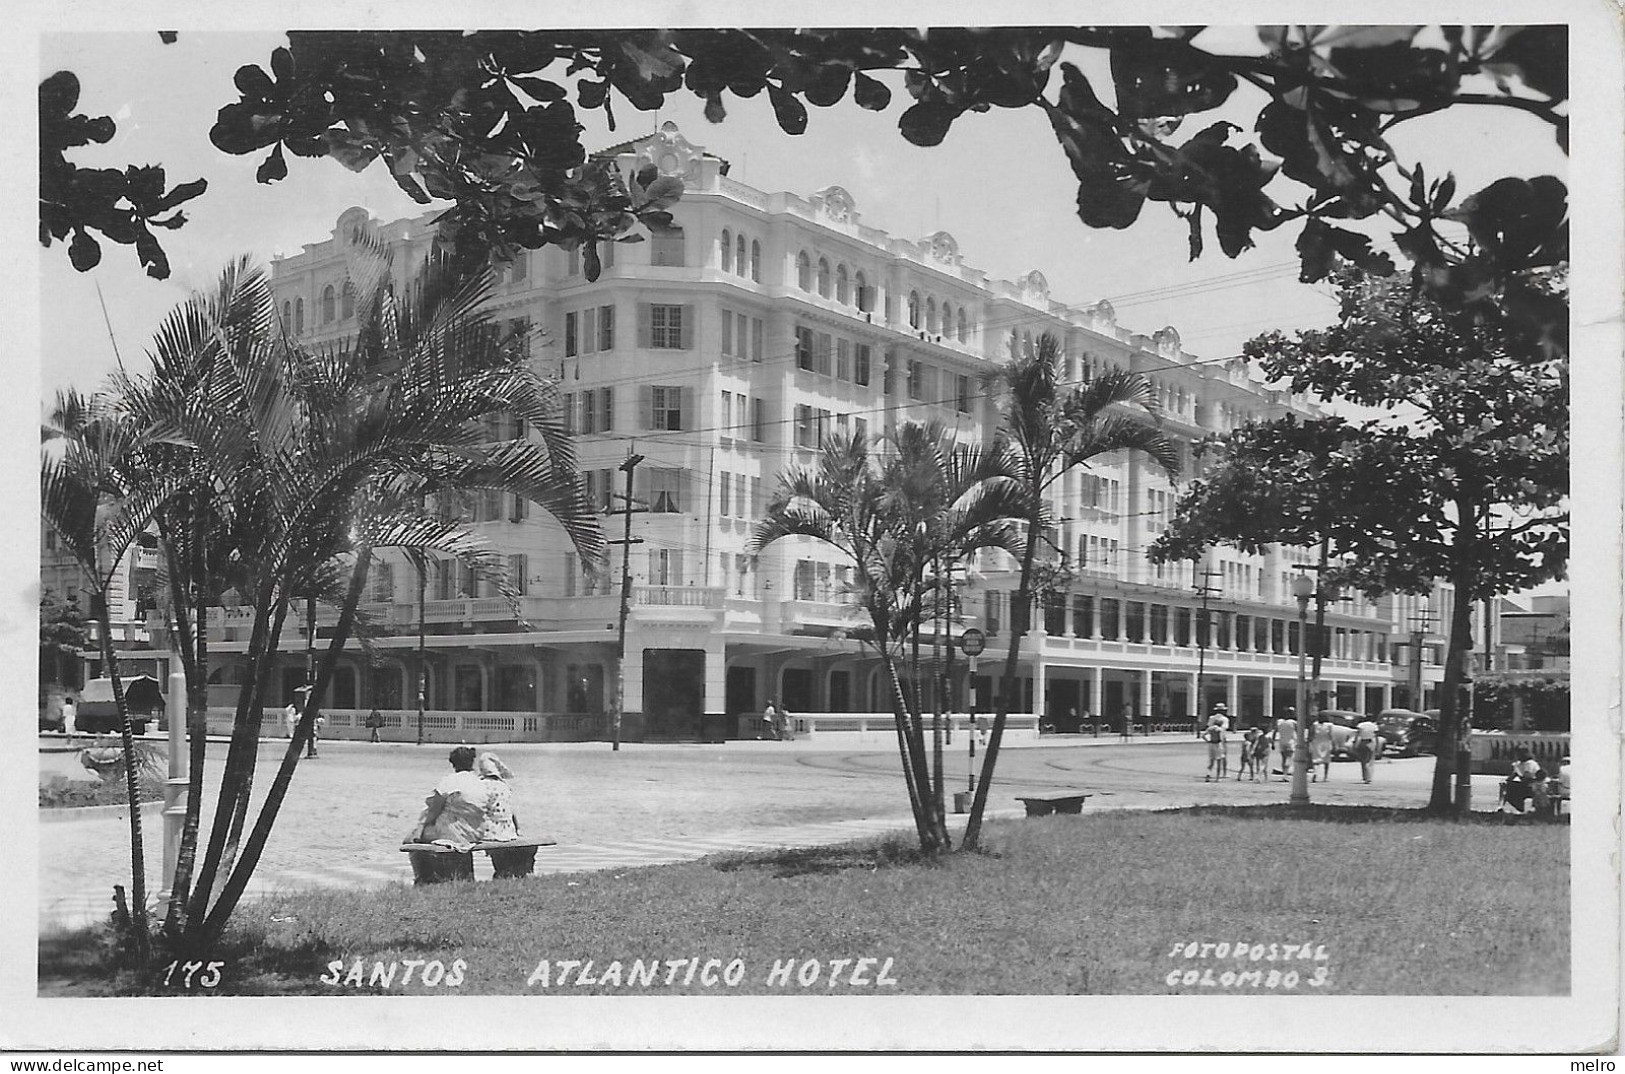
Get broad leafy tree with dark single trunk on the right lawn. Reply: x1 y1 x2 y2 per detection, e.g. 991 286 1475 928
1152 268 1568 809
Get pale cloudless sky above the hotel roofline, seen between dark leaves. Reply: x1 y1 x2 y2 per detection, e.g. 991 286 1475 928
36 28 1567 403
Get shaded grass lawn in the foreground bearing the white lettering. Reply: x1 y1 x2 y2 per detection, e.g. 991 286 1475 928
41 806 1570 996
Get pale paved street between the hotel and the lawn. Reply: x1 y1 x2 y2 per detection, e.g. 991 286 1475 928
37 736 1495 929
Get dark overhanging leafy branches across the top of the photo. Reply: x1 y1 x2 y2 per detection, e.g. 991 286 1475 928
42 26 1568 351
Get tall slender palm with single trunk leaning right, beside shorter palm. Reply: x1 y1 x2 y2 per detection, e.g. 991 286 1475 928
962 333 1178 850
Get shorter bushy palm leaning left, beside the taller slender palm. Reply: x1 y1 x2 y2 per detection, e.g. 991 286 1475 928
751 422 1021 853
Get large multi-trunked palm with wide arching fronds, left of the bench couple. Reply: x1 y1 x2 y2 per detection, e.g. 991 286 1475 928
108 246 603 951
